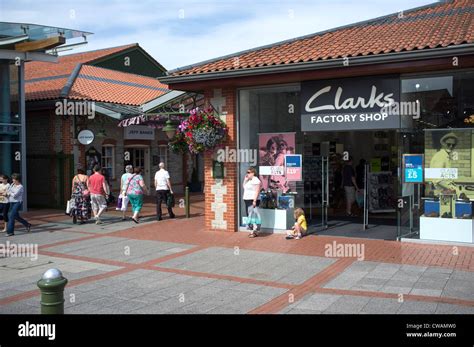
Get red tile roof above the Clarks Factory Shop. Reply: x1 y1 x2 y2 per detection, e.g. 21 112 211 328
171 0 474 76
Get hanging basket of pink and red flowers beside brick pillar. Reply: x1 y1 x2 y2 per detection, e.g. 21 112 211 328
169 108 228 154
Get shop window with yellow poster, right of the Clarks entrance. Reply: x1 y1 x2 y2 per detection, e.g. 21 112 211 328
401 67 474 243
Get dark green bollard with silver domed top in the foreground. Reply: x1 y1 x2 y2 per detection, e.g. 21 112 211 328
37 269 67 314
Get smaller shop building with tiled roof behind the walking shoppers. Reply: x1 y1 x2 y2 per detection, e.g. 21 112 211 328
25 44 203 209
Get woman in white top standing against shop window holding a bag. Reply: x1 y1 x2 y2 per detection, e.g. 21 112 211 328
243 167 262 237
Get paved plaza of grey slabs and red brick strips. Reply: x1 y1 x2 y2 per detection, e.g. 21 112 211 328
0 204 474 314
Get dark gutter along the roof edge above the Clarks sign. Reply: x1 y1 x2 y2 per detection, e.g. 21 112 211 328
158 43 474 84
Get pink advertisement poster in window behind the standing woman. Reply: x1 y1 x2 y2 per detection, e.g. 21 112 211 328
258 133 295 193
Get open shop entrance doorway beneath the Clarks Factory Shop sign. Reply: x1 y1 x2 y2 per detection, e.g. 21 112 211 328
302 131 399 240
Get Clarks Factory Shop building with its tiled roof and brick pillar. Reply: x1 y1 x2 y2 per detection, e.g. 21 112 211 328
160 1 474 243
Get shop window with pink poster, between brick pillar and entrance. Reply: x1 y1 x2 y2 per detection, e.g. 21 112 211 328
239 86 303 229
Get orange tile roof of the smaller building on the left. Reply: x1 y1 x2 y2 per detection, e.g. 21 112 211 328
25 44 169 106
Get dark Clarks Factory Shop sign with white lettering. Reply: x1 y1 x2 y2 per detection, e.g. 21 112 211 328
301 76 400 131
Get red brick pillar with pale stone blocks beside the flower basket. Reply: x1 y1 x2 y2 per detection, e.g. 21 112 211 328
204 88 238 231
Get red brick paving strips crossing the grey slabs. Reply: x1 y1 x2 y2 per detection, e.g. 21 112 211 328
0 211 474 313
